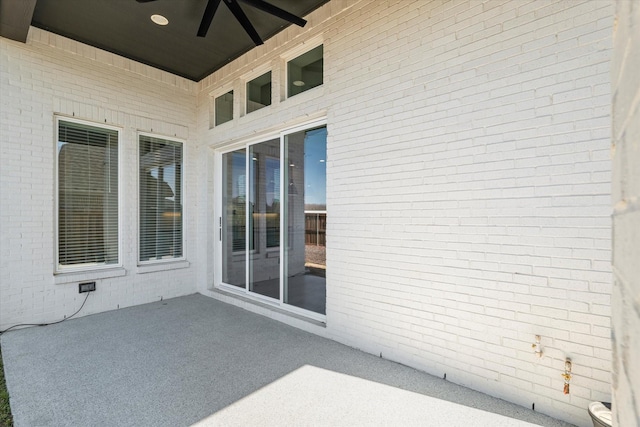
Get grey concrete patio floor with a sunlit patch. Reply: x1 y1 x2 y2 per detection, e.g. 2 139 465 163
1 294 569 427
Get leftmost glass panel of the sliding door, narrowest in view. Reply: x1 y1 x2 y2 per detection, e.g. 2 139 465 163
218 149 247 288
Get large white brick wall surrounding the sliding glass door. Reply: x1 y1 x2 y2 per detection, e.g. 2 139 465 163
198 0 613 426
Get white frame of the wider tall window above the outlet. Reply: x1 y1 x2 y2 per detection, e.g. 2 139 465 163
53 114 124 275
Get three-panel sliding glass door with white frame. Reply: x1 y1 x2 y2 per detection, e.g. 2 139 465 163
218 126 327 314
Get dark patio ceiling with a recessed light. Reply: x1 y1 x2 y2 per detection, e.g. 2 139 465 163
1 0 328 81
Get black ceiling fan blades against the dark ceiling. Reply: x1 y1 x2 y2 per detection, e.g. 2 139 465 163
136 0 307 45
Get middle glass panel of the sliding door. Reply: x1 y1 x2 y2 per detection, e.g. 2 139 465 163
248 139 281 300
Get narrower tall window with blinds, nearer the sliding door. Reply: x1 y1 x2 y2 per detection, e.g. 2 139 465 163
139 135 183 262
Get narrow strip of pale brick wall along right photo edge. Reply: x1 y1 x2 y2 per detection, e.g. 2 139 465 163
611 0 640 426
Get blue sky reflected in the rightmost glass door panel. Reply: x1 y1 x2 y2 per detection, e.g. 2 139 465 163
304 128 327 205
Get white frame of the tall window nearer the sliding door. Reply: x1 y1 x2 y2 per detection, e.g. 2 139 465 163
136 132 185 267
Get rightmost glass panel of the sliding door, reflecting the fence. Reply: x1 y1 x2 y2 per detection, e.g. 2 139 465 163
283 127 327 314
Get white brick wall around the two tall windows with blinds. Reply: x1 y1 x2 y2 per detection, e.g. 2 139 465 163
0 28 198 329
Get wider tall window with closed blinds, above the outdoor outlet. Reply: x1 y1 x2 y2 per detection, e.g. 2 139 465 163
56 119 120 272
